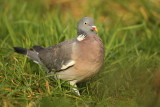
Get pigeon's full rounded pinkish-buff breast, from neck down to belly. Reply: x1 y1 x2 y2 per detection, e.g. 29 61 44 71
72 35 104 79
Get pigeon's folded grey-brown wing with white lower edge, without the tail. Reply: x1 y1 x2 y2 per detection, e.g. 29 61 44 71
33 39 76 71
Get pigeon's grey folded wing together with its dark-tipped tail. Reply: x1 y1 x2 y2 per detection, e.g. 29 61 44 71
14 39 75 72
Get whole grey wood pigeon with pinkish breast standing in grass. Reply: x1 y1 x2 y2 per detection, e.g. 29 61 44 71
14 17 104 95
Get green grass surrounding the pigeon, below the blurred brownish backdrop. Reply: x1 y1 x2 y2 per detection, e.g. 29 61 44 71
0 0 160 107
